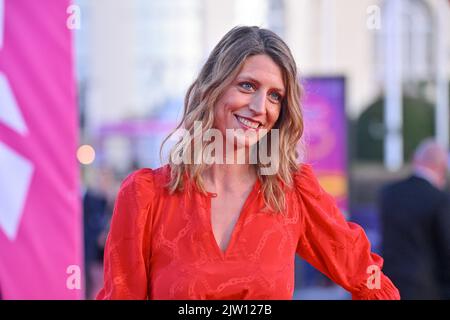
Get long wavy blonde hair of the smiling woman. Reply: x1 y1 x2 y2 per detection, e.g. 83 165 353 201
160 26 303 212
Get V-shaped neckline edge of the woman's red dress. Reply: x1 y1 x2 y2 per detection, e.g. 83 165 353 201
206 178 260 260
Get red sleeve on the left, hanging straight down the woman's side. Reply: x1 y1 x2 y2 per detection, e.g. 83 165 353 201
97 169 154 300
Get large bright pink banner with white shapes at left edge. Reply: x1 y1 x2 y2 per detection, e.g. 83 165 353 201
0 0 82 299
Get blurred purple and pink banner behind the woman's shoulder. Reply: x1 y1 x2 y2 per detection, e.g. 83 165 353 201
304 77 348 214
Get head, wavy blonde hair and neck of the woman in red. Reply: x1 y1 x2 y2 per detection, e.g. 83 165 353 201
161 27 303 212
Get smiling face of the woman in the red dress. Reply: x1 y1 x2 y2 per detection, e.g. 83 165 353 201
214 55 285 147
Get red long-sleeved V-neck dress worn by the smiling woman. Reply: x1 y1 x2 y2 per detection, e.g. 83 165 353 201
97 165 399 300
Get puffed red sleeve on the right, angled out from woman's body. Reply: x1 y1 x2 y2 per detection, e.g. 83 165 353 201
294 165 400 300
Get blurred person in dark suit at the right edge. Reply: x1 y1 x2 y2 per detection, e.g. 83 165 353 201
379 139 450 299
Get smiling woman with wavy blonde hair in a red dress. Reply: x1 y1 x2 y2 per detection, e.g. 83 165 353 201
98 27 399 299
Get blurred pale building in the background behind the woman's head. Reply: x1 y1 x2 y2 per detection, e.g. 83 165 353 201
77 0 450 170
